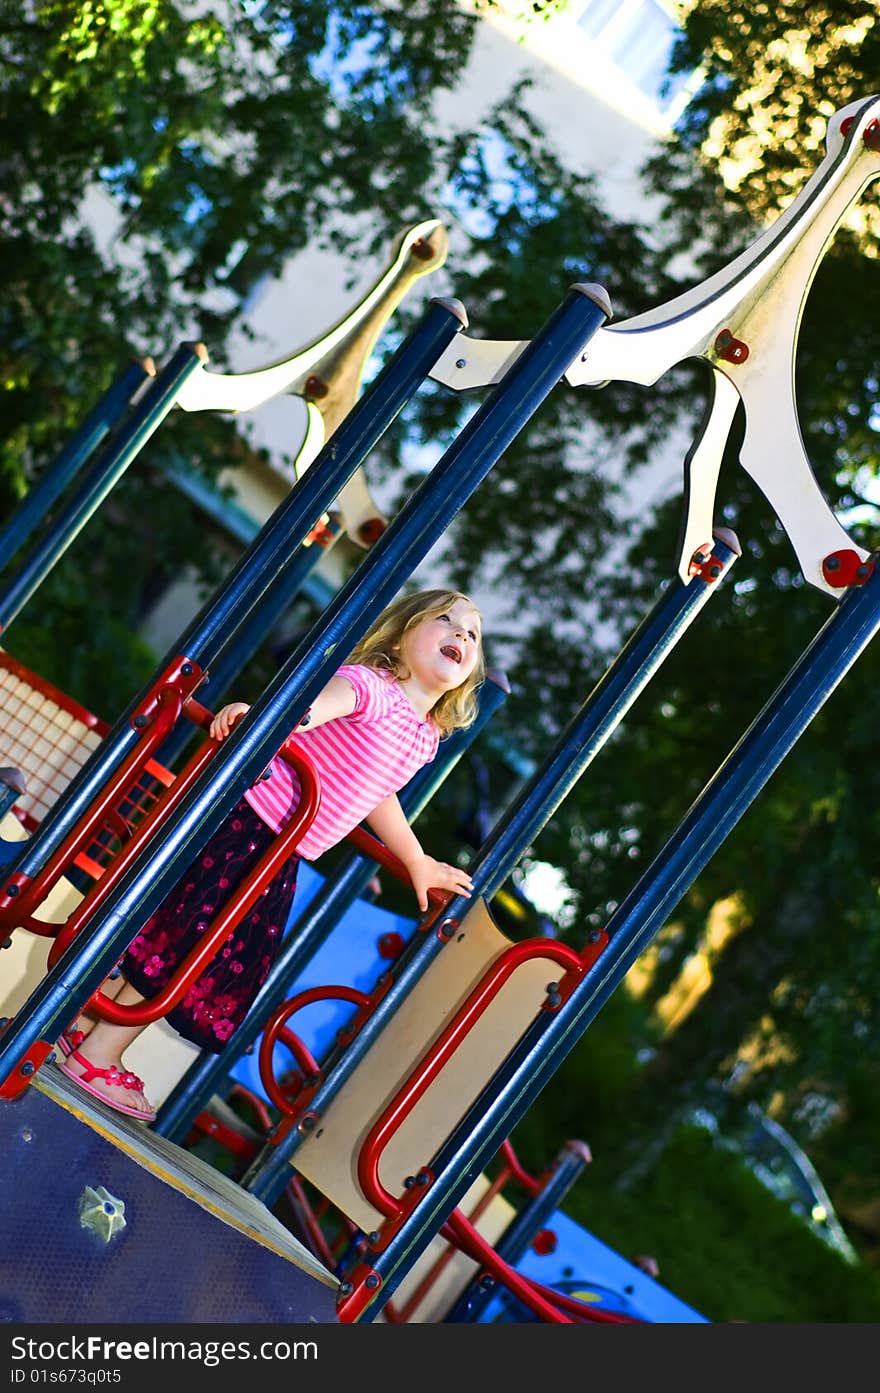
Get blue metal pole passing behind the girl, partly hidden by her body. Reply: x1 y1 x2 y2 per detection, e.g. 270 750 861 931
153 673 510 1142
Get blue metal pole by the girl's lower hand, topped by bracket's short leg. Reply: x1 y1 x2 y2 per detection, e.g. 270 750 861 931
242 529 739 1199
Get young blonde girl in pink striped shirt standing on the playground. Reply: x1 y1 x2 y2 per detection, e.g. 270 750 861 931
58 589 485 1121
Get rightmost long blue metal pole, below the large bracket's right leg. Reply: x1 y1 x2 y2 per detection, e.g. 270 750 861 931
365 556 880 1319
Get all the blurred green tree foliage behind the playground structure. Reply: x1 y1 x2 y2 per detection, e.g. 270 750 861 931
0 0 880 1292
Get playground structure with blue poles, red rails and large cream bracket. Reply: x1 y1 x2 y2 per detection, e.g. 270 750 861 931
0 99 880 1323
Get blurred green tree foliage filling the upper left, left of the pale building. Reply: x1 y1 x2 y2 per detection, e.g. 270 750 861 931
0 0 626 717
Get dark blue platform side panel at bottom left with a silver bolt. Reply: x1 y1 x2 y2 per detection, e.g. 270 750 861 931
0 1088 337 1328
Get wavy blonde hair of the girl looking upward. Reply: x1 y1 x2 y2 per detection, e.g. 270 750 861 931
347 591 486 736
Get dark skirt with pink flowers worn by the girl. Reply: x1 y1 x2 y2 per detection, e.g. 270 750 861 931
120 798 299 1055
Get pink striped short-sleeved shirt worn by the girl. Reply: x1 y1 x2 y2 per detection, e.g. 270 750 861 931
245 663 440 861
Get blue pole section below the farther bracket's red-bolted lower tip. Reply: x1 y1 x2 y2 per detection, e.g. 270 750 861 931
156 518 344 769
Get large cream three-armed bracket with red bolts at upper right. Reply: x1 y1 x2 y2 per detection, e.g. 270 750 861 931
432 96 880 599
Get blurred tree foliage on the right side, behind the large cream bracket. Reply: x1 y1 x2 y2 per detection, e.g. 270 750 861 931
375 0 880 1281
